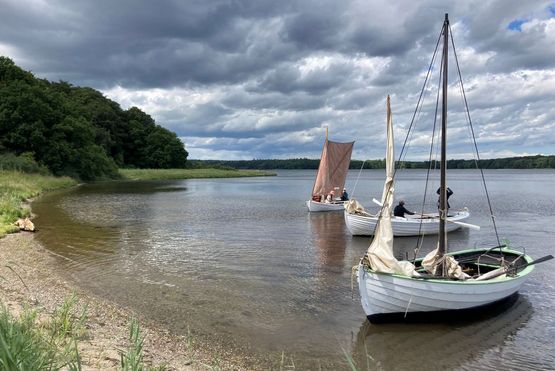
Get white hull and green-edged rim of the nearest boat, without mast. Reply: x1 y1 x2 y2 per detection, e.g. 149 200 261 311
357 249 534 322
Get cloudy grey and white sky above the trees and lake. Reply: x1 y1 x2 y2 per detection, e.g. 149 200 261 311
0 0 555 159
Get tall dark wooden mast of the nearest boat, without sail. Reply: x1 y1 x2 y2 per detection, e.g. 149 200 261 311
438 13 449 275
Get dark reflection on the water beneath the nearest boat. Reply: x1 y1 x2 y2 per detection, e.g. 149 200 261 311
352 294 533 370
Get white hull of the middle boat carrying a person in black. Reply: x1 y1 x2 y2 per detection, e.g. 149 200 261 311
345 210 470 236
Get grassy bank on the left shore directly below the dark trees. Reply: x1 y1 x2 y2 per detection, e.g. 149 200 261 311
0 171 77 237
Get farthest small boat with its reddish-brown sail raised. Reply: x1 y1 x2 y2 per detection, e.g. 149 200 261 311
306 128 355 212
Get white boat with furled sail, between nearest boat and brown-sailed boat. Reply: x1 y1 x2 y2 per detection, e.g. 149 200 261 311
345 96 472 236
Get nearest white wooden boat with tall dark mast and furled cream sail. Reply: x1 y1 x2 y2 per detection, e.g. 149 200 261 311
357 14 553 322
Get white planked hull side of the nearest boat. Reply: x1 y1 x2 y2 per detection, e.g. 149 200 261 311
358 250 533 320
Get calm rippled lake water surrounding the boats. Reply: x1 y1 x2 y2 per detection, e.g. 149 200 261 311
33 170 555 370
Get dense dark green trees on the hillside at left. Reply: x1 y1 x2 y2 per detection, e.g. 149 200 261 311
0 57 188 180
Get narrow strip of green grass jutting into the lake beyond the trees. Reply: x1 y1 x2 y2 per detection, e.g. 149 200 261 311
119 169 276 180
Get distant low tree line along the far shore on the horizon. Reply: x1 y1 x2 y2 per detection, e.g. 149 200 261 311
189 155 555 170
